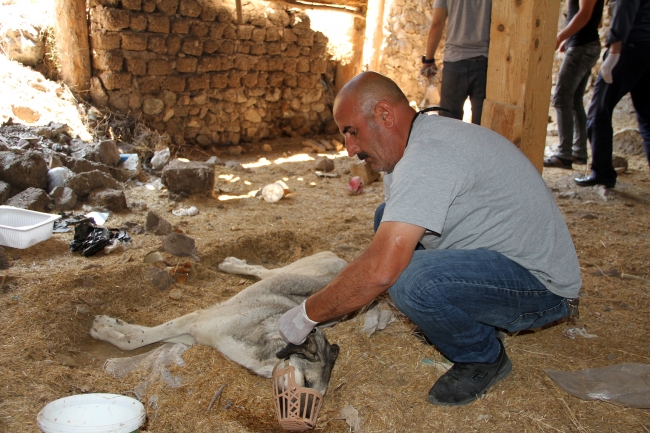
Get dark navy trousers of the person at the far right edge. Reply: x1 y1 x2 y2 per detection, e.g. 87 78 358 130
587 42 650 181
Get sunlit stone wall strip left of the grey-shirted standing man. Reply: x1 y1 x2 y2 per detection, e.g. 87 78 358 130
379 0 432 104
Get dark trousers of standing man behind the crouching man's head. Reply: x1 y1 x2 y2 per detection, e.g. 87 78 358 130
440 56 487 125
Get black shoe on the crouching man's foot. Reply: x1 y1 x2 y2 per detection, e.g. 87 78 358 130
429 341 512 406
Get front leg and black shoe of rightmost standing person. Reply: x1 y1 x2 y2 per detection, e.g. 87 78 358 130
575 43 650 187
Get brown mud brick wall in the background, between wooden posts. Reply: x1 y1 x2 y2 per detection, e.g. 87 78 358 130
89 0 332 146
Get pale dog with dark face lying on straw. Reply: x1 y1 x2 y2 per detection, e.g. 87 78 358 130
90 252 347 395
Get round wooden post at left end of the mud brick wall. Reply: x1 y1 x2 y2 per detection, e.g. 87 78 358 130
55 0 91 98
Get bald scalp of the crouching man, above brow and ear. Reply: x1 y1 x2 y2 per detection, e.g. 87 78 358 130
334 71 409 118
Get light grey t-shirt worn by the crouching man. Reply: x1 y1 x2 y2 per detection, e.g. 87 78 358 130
382 115 581 298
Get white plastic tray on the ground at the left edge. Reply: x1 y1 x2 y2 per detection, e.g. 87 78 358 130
0 206 61 248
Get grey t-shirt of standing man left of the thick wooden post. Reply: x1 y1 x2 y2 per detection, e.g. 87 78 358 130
433 0 492 62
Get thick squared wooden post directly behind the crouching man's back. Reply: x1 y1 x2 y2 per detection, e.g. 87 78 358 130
481 0 560 173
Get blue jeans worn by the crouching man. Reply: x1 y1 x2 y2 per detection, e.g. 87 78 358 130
375 203 569 362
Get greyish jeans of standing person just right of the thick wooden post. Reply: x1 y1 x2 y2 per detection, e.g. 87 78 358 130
553 42 600 161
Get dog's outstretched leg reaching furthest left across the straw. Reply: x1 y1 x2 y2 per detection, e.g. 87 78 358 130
90 311 199 350
